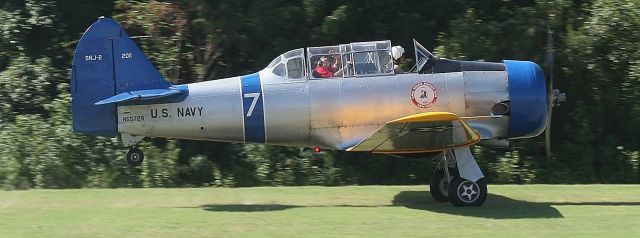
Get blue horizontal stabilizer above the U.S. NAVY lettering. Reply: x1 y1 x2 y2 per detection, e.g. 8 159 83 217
95 85 189 105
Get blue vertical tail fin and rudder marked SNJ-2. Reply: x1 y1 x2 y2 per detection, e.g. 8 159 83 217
71 17 172 137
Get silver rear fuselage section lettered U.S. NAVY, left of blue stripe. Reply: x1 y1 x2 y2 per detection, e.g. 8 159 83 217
118 78 243 142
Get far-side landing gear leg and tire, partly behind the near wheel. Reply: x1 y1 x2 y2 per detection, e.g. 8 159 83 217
429 150 460 202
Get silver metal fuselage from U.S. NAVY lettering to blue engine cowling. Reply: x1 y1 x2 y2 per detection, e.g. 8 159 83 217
117 70 509 150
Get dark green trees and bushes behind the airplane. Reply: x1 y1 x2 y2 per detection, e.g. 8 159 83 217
0 0 640 189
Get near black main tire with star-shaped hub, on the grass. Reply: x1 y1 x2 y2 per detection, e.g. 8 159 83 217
449 177 488 207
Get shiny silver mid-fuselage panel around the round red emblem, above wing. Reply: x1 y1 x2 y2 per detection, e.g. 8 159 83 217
309 72 464 149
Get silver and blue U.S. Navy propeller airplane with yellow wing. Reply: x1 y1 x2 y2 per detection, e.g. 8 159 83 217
71 17 564 206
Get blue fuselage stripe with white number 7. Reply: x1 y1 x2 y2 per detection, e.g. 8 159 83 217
240 73 265 143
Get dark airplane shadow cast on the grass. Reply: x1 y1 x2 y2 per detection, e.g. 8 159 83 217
200 191 640 219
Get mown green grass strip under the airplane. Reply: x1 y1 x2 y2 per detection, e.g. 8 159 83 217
0 185 640 238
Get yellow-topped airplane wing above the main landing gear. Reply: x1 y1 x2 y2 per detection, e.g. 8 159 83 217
347 112 480 154
